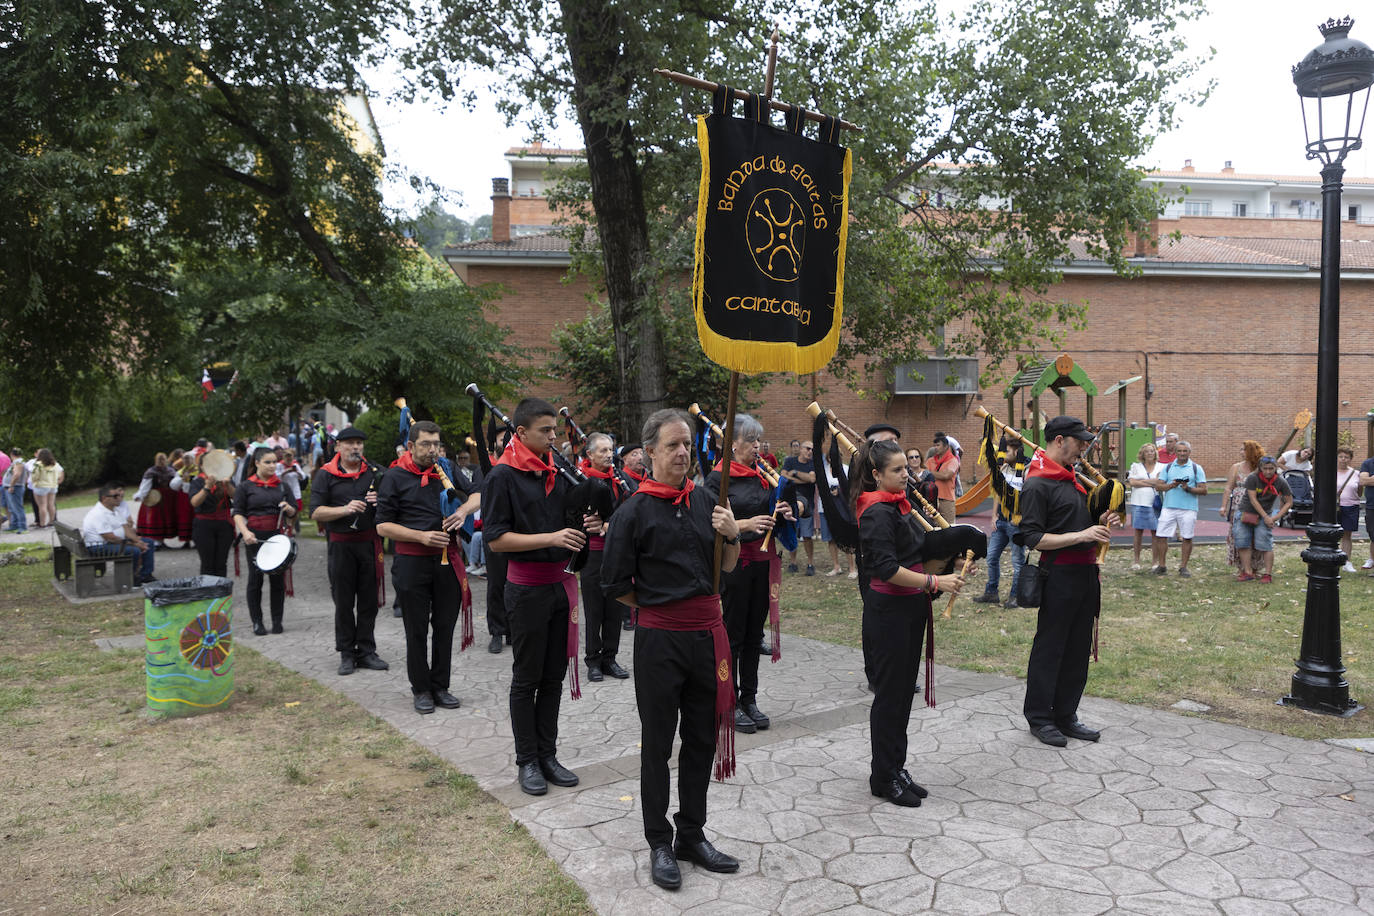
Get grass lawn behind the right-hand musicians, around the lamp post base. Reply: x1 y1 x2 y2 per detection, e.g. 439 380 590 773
782 544 1374 737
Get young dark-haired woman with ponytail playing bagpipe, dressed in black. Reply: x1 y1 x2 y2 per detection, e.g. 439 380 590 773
851 441 988 808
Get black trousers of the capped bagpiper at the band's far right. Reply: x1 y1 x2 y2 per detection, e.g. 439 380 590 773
1024 566 1102 728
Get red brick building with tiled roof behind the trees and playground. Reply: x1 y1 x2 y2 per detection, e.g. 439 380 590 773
445 148 1374 478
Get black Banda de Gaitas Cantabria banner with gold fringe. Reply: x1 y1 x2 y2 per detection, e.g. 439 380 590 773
692 87 852 374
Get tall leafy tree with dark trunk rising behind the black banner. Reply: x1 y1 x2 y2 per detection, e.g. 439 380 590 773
408 0 1201 428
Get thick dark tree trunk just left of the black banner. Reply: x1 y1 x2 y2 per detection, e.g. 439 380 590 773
561 0 666 441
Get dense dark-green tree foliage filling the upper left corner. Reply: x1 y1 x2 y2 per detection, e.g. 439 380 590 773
0 0 515 428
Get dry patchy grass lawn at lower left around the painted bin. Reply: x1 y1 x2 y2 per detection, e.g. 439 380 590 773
0 548 591 915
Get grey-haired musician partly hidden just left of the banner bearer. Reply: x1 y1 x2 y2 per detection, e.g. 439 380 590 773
574 431 638 681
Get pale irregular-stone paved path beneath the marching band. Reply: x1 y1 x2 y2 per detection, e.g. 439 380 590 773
40 516 1374 916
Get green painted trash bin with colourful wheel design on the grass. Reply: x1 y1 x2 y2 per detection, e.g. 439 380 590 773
143 575 234 715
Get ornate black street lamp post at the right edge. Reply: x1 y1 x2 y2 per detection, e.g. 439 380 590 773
1279 16 1374 715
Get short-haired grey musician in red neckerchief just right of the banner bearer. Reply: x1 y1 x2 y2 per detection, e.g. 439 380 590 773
692 414 801 735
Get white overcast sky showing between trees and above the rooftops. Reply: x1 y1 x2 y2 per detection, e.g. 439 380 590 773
372 0 1374 218
